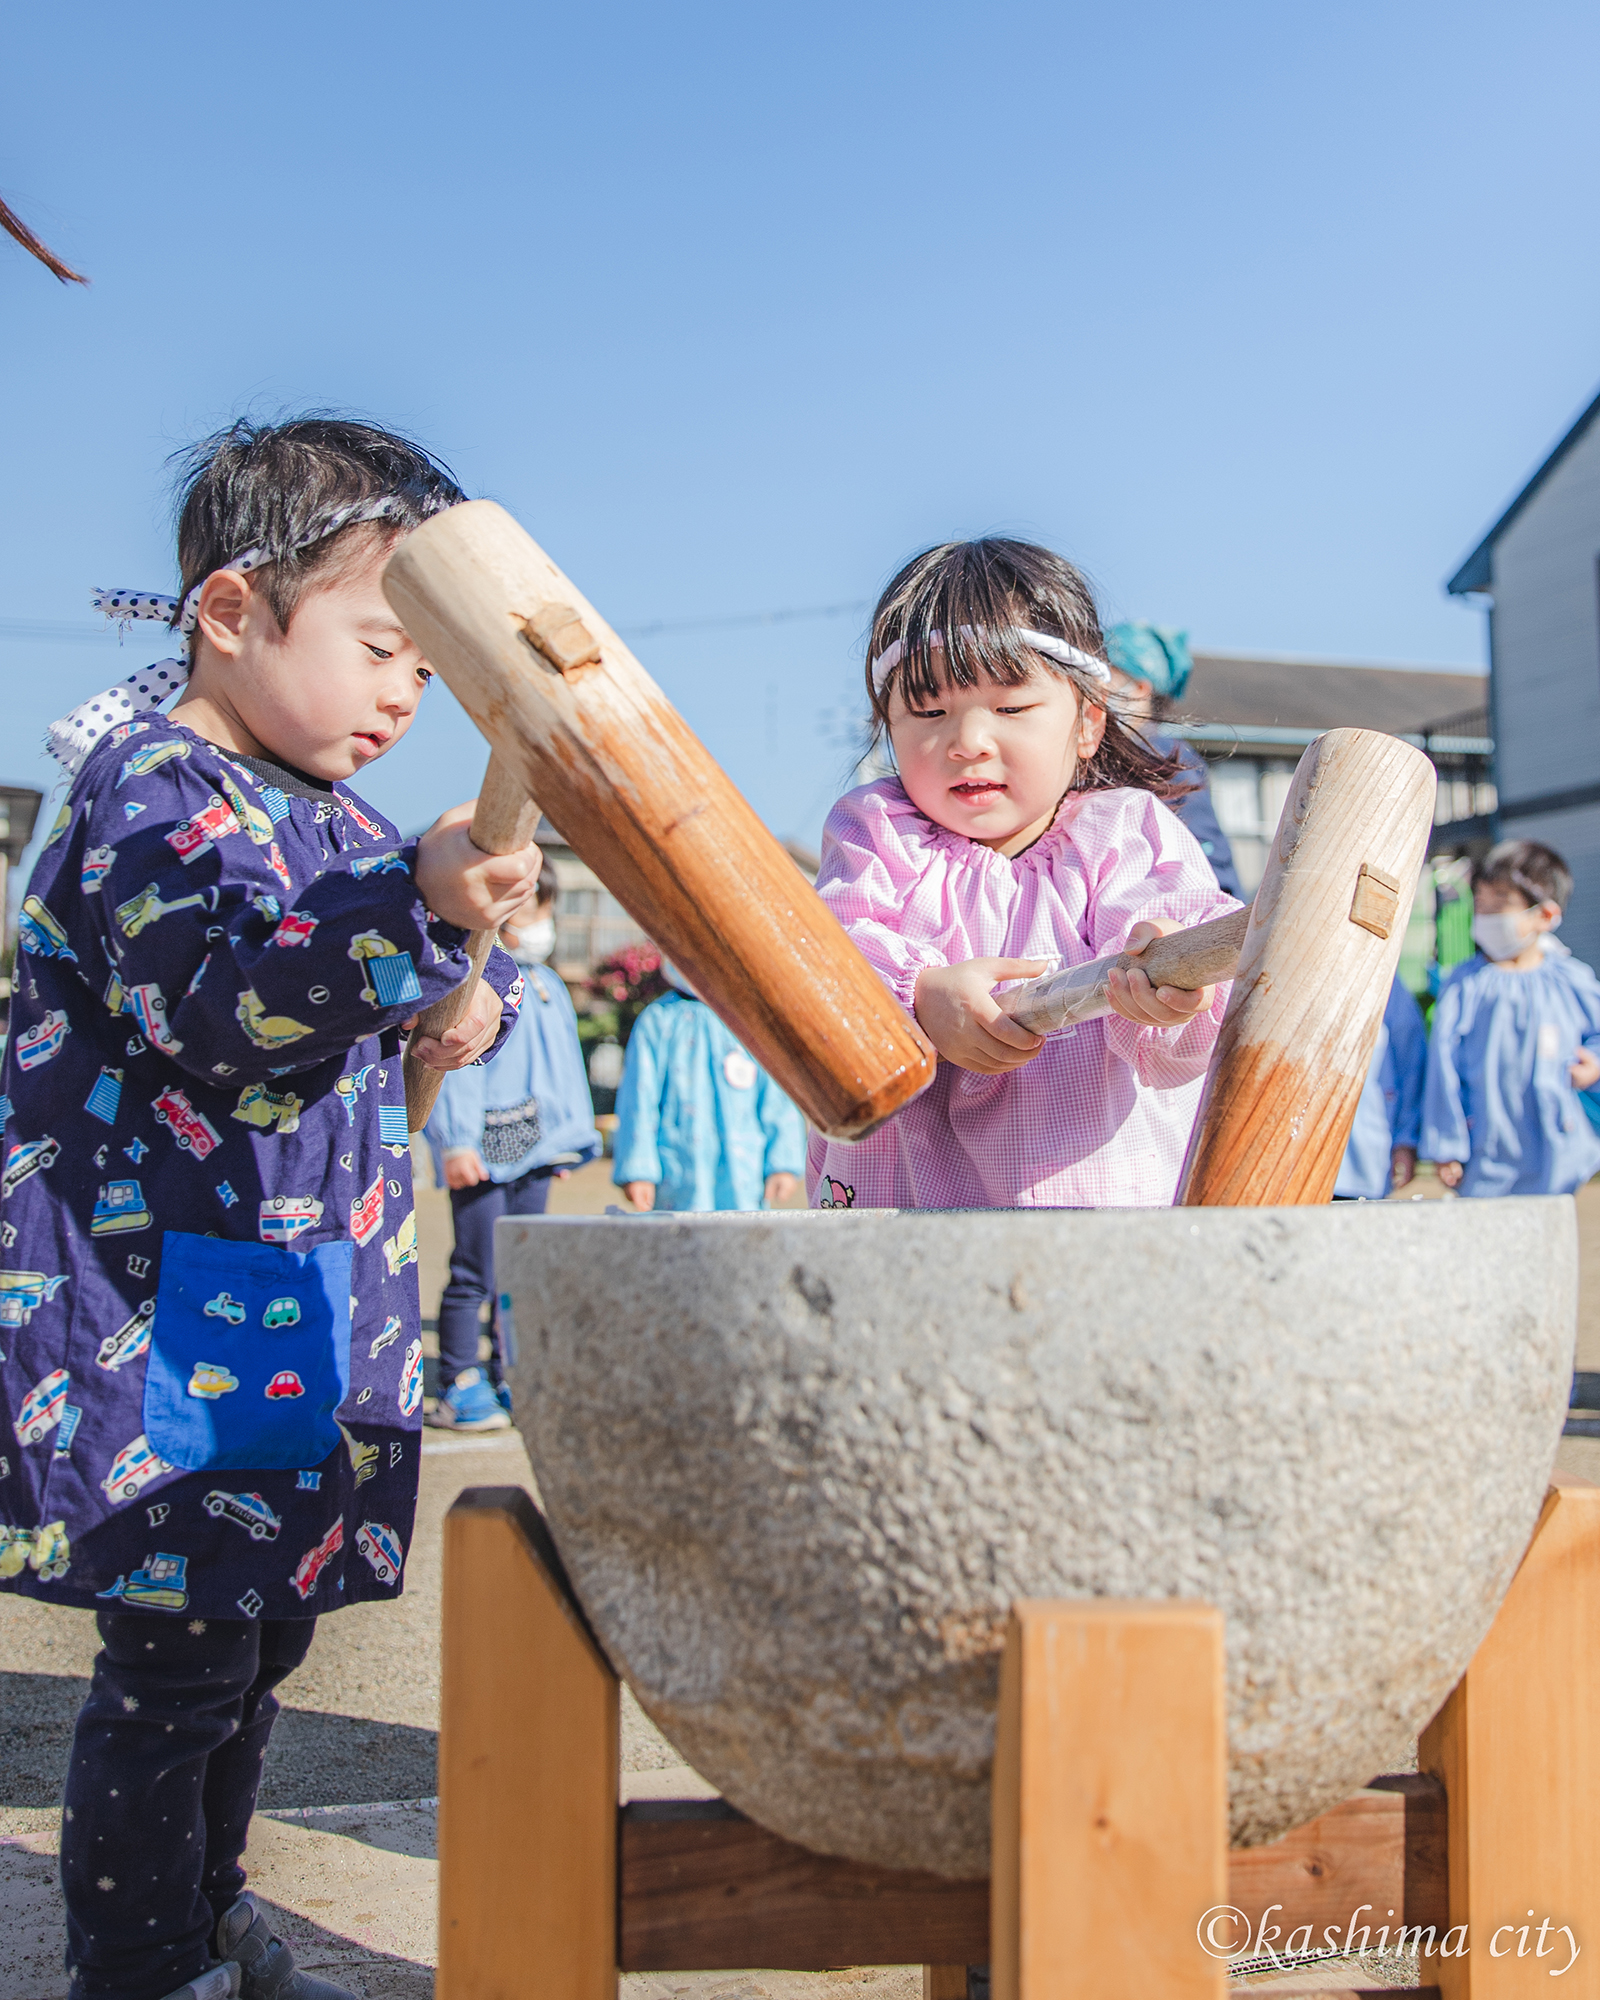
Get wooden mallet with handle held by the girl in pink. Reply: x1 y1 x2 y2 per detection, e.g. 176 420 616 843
1000 730 1434 1208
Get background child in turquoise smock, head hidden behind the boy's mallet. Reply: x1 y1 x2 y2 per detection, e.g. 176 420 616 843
612 962 806 1212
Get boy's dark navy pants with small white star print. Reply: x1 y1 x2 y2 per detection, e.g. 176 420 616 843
62 1610 316 2000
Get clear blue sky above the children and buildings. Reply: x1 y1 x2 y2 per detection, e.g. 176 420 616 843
0 0 1600 864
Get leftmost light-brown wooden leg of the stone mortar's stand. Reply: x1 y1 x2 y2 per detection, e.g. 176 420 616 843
436 1486 618 2000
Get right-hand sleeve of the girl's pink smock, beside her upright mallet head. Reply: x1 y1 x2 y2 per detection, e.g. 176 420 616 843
1088 792 1238 1090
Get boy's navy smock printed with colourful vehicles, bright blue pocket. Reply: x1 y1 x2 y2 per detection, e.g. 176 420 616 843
0 716 518 1618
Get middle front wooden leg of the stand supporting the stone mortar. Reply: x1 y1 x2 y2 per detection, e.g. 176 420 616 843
990 1598 1228 2000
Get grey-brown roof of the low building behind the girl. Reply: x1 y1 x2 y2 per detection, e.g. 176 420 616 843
1172 652 1488 748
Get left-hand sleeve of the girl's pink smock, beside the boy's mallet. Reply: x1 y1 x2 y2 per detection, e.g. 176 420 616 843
816 786 950 1014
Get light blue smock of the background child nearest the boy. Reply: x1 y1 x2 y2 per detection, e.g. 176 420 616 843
428 966 600 1182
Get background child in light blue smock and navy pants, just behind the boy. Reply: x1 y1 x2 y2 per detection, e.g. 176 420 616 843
428 862 600 1430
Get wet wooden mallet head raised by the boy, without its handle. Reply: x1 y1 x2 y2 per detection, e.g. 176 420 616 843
384 500 936 1138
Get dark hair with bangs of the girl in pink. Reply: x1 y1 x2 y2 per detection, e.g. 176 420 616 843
866 536 1194 800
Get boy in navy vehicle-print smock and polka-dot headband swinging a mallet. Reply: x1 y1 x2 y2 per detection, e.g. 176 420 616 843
0 418 538 2000
